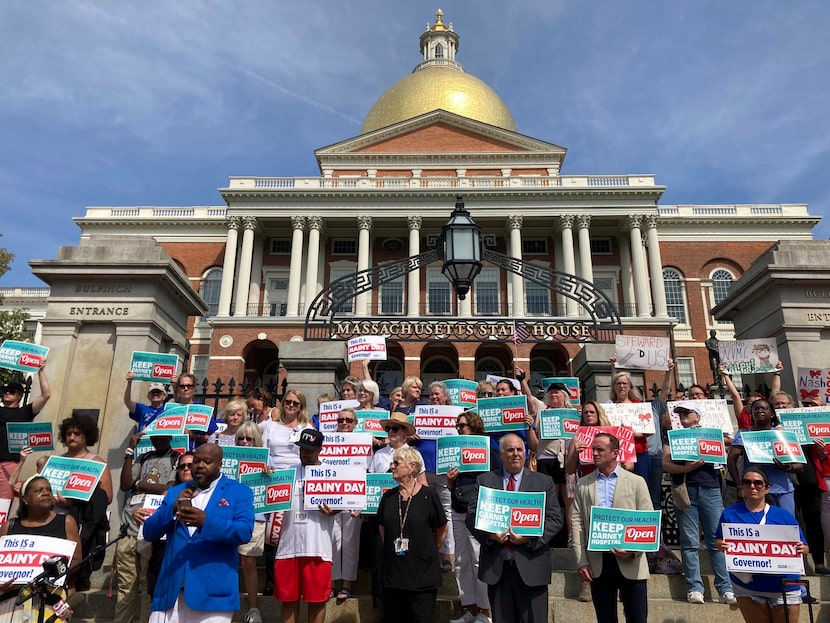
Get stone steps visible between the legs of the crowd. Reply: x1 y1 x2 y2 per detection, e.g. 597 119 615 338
66 549 830 623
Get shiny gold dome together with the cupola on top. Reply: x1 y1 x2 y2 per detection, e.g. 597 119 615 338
361 9 516 134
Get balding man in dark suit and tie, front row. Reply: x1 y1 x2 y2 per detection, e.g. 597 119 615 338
466 434 563 623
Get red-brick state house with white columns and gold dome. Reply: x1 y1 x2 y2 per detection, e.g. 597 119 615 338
71 11 819 398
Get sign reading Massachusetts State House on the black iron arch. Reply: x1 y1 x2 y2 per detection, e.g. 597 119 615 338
332 318 618 343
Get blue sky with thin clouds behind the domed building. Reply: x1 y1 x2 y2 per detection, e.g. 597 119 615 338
0 0 830 286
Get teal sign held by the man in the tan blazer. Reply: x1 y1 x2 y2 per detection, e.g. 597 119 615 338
587 506 662 552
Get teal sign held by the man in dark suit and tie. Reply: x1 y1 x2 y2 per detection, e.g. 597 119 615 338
476 487 545 536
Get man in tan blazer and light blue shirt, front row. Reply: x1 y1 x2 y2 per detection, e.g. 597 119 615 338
571 433 653 623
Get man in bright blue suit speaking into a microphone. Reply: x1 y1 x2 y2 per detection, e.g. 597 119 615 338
144 444 254 623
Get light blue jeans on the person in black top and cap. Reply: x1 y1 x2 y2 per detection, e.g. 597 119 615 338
677 487 732 595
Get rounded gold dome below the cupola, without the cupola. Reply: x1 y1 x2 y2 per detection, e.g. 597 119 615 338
361 66 516 134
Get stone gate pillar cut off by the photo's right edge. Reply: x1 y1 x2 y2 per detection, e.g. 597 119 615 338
712 240 830 400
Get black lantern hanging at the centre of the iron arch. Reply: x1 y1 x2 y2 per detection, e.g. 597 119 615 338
441 195 481 301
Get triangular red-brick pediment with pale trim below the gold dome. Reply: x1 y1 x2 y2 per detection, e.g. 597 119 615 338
315 110 567 171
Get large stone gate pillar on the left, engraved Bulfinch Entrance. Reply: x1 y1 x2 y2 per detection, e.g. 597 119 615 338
30 236 207 526
